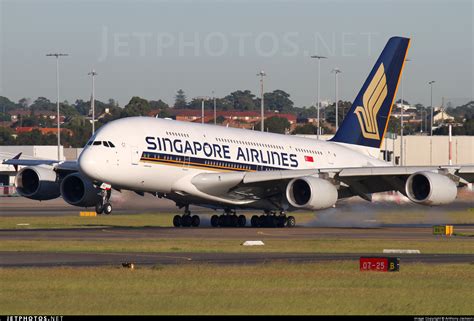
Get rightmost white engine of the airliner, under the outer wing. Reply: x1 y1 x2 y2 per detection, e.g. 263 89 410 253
405 172 458 205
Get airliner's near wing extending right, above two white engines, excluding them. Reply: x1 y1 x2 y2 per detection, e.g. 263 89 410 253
191 165 474 202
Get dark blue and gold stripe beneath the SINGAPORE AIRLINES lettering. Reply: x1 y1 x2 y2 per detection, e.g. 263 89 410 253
140 152 289 172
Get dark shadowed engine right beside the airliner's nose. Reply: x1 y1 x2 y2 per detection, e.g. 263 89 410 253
61 173 101 207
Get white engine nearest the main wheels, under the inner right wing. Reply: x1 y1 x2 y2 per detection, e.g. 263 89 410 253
286 176 338 210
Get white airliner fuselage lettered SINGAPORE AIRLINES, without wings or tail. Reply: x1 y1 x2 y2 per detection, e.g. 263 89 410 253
79 117 387 193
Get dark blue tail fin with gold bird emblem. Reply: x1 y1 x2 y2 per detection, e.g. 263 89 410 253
331 37 410 148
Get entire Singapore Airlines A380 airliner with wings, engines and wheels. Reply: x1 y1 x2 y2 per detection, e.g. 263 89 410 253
4 37 474 227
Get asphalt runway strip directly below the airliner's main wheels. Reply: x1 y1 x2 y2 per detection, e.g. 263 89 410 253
0 225 474 242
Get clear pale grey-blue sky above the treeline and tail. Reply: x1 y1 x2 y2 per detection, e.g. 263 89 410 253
0 0 474 106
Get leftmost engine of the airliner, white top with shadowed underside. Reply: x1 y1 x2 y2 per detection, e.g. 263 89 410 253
15 165 60 201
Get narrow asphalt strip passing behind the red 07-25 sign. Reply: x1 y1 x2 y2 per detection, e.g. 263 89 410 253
0 252 474 268
